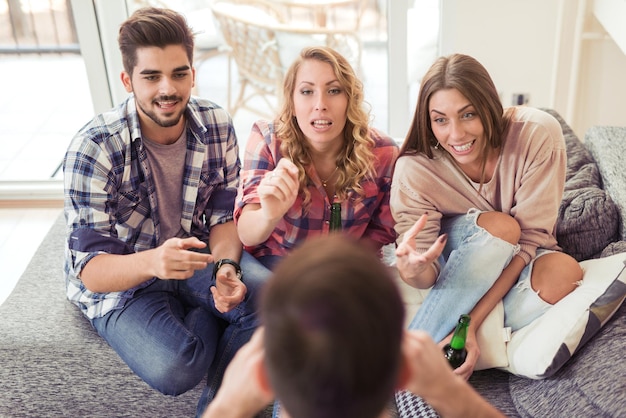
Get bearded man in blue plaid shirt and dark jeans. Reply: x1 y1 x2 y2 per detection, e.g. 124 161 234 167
63 8 269 402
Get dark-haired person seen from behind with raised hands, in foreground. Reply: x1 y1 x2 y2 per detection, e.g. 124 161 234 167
202 235 503 418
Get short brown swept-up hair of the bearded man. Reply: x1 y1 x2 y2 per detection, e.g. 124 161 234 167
117 7 194 75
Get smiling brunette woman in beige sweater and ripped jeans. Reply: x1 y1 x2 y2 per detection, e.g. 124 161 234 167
391 54 582 378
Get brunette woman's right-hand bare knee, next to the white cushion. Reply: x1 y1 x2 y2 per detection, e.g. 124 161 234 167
531 252 583 304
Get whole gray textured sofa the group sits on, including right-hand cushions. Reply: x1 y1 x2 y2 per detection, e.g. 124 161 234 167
0 112 626 417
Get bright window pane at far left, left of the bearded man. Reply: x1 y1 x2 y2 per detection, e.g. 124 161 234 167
0 0 93 202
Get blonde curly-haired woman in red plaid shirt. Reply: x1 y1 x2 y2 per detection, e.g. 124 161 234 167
235 47 398 268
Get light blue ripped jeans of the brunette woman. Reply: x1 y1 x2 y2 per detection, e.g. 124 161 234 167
409 209 552 342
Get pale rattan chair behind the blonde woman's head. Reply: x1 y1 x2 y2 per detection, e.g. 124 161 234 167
212 0 361 119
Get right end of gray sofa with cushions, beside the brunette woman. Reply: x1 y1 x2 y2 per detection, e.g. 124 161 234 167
470 110 626 417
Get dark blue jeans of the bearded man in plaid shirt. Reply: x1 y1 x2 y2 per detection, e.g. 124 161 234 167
92 252 270 395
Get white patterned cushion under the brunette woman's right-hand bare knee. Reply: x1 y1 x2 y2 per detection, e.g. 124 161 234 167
504 253 626 379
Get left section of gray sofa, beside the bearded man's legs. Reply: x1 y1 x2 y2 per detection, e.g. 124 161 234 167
0 216 202 417
